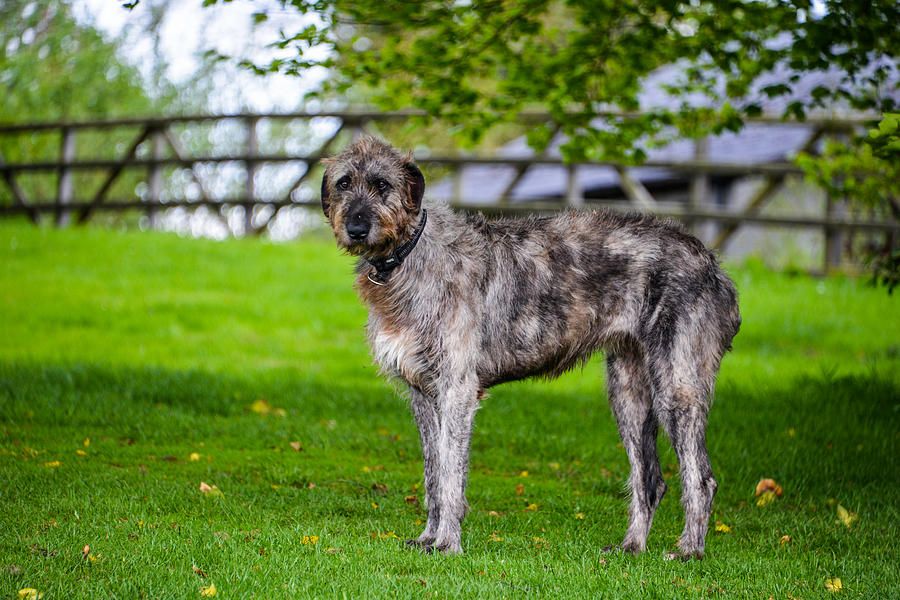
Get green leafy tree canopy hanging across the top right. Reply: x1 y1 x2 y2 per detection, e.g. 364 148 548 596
193 0 900 160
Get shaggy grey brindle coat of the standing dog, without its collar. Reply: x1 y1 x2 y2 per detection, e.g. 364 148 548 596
322 138 740 558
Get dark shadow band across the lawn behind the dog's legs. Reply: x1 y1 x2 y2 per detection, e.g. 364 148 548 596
0 363 900 502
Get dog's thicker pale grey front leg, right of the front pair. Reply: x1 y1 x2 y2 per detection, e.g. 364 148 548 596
429 380 478 554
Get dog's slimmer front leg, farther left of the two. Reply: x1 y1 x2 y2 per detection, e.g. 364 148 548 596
406 388 441 548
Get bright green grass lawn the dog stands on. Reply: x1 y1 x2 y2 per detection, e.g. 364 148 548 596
0 222 900 599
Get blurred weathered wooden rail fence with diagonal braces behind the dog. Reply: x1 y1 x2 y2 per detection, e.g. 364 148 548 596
0 112 900 268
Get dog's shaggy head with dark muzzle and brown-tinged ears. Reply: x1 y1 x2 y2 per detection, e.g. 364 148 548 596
322 137 425 255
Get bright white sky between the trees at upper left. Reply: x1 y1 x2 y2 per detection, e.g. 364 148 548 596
71 0 324 112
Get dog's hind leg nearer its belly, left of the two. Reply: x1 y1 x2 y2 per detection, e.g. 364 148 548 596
607 347 666 553
